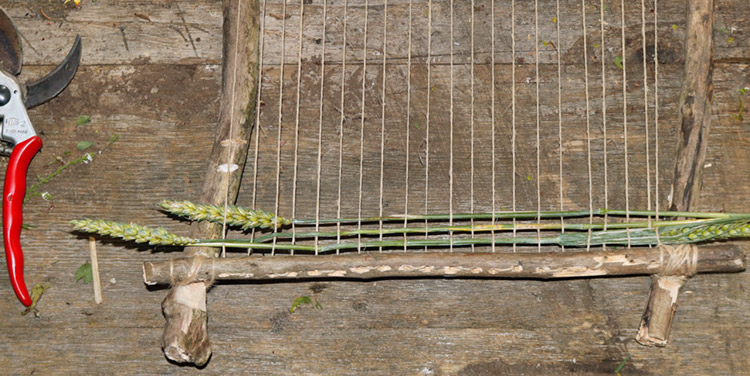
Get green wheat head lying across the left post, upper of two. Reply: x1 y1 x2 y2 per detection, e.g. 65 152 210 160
159 200 292 230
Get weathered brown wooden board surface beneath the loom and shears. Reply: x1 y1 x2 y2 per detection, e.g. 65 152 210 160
0 0 750 375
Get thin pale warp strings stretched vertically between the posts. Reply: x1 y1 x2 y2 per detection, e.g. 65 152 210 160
251 0 659 254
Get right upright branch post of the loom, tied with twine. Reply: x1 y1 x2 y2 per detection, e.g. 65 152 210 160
636 0 714 346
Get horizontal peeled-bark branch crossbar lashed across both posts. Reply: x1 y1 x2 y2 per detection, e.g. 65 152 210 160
143 244 745 285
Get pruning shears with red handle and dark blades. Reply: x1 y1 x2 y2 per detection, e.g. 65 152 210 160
0 8 81 307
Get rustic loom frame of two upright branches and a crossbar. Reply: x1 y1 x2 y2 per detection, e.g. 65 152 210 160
144 0 745 365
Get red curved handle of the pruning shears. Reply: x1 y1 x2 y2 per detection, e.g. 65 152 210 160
3 136 42 307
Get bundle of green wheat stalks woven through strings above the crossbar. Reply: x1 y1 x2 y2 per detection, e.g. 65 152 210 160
71 201 750 254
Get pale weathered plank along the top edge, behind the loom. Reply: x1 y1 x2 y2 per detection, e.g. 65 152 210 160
4 0 750 65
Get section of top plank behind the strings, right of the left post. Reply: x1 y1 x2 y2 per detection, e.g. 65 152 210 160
254 0 750 64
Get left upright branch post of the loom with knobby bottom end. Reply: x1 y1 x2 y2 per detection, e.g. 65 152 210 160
162 0 260 367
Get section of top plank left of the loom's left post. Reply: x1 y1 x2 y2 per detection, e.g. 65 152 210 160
3 0 222 65
